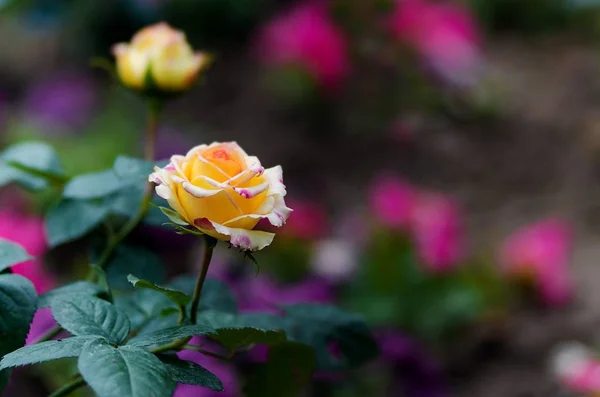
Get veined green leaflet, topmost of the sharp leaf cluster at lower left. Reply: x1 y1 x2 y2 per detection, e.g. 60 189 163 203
52 295 130 344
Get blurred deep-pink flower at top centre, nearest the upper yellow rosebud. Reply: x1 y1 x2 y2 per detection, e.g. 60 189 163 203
258 1 349 89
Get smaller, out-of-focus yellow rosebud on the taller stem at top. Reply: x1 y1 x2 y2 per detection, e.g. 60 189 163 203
113 22 210 92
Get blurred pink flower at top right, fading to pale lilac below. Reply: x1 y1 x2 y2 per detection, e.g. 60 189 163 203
388 0 482 86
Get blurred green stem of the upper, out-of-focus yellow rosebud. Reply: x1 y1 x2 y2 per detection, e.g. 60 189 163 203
96 99 162 269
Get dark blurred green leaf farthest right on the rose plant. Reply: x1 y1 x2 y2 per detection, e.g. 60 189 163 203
284 304 379 369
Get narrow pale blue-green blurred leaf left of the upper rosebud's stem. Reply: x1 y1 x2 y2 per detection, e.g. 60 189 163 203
63 169 123 200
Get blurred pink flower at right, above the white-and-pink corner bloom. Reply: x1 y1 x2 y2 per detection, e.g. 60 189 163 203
499 219 573 305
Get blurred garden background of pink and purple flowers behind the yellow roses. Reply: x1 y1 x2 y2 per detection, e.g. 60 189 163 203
5 0 600 397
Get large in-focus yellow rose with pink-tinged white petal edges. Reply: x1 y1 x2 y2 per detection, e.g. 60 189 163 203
149 142 292 251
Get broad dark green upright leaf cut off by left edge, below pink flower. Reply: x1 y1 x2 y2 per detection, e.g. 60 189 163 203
0 274 36 391
